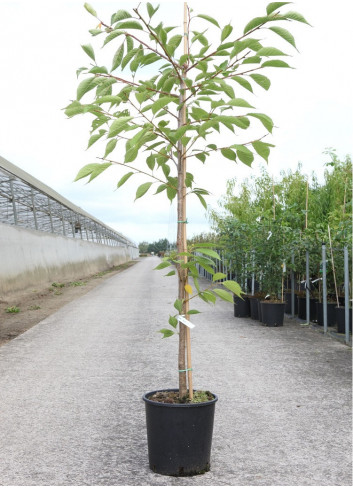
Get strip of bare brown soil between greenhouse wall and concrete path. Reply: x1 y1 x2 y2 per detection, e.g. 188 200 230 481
0 261 136 346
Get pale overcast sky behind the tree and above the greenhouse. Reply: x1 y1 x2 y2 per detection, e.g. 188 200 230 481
0 0 353 243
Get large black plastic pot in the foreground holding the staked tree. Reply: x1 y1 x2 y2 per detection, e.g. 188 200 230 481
142 389 218 477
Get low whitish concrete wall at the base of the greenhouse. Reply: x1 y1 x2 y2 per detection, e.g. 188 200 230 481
0 223 138 299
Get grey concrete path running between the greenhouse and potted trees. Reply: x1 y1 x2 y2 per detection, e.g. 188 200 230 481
0 258 352 486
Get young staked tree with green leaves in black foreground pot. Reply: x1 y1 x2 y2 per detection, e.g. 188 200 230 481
65 2 307 476
